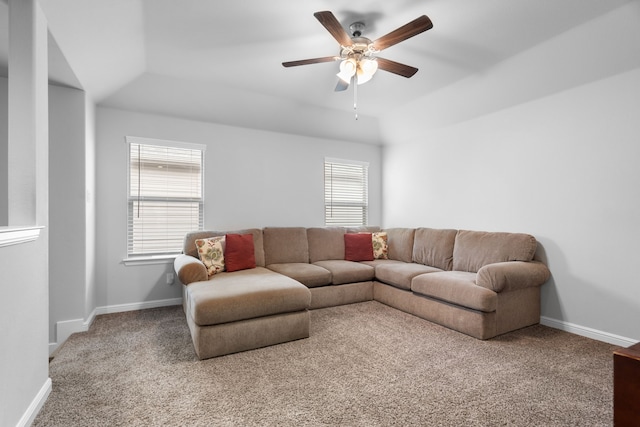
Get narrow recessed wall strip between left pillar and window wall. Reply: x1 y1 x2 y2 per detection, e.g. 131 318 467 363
49 85 89 350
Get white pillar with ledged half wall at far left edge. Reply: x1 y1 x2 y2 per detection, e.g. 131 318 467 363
0 0 51 426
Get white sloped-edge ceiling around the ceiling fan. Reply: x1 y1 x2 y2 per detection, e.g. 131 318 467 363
0 0 631 143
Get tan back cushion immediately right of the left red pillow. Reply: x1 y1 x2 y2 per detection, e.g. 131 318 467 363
262 227 309 265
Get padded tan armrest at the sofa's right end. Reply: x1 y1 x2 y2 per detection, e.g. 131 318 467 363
476 261 551 292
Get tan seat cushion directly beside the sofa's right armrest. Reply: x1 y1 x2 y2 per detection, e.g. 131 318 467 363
411 271 498 313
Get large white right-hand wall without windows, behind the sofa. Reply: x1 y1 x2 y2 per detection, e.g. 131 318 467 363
383 2 640 342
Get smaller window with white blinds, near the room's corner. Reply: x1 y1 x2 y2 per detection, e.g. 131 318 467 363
324 158 369 226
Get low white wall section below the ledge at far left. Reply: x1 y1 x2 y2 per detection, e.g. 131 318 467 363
0 239 51 426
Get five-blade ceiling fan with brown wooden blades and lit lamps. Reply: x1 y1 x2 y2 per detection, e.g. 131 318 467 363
282 11 433 91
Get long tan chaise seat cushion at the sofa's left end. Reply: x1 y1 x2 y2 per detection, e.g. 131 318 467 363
186 267 311 326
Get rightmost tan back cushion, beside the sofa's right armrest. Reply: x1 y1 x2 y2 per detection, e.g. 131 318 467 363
453 230 537 273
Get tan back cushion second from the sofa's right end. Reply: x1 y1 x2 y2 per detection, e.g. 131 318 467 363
413 228 458 271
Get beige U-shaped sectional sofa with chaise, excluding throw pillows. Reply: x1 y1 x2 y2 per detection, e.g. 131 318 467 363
175 227 550 359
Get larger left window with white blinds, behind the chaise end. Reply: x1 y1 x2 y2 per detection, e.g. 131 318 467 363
126 137 205 257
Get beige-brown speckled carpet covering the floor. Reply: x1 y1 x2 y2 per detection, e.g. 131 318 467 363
34 302 615 427
